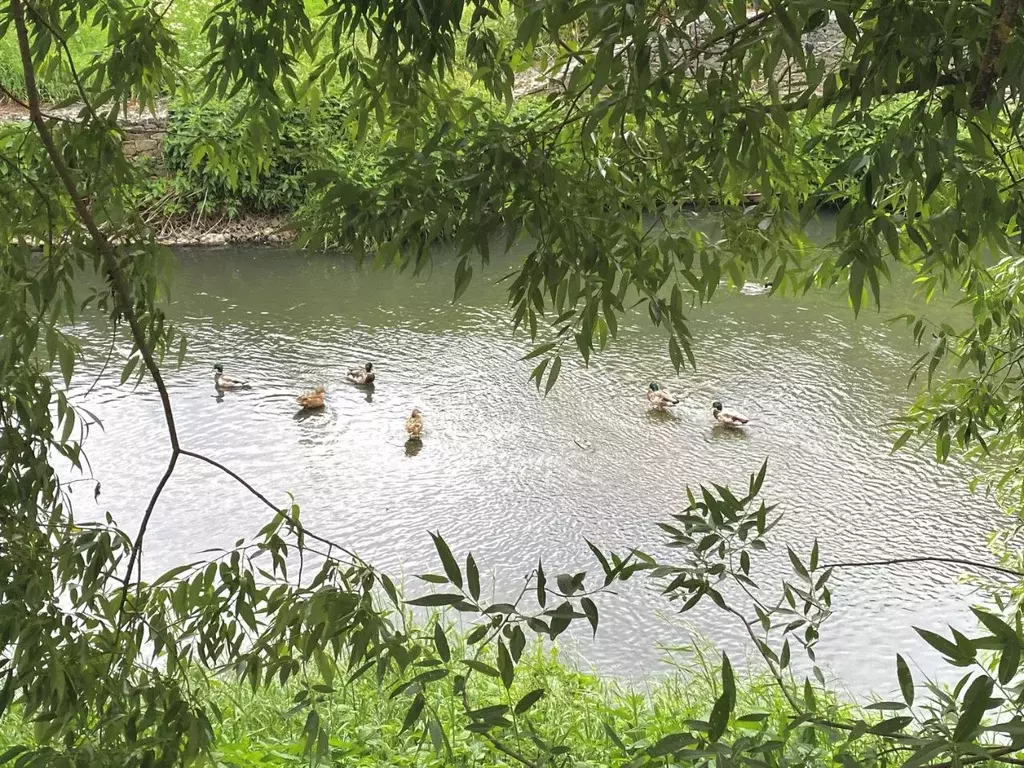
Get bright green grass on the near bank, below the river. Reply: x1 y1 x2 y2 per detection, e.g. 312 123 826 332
0 645 872 768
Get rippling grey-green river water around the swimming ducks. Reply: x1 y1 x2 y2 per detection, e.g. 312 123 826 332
72 244 1000 695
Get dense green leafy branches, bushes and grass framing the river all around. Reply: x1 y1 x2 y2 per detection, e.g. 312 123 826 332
0 0 1024 768
